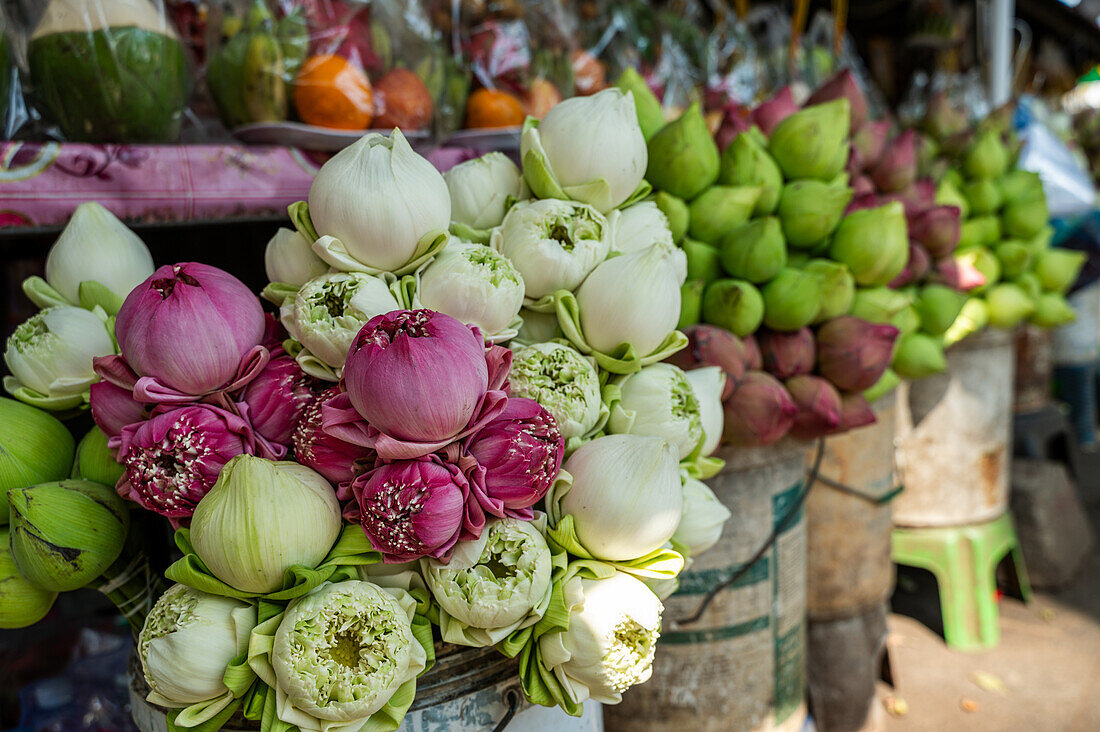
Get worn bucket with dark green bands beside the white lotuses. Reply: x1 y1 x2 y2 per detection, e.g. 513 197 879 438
604 440 806 732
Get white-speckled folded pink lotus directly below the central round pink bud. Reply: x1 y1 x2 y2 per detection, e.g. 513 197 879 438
338 455 470 562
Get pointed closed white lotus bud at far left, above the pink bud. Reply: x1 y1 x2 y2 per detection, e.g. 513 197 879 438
46 201 153 305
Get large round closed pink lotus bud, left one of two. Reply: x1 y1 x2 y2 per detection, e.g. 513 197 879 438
114 262 264 396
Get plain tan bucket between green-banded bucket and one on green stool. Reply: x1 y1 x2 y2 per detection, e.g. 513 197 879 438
806 394 897 620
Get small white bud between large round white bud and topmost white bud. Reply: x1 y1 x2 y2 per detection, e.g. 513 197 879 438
443 152 530 229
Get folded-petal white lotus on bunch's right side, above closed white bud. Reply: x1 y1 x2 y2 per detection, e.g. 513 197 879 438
607 363 703 460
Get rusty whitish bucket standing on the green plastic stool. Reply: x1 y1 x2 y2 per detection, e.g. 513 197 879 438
893 329 1015 526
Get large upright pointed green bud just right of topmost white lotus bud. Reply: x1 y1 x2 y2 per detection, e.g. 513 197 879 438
646 102 719 200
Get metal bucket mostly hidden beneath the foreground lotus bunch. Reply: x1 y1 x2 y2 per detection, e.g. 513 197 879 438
130 645 604 732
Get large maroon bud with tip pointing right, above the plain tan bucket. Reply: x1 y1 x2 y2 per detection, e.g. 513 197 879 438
817 315 898 392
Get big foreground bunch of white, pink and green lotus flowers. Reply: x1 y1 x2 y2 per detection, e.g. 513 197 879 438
0 89 729 732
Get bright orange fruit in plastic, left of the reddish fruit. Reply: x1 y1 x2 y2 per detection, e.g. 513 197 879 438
294 54 374 130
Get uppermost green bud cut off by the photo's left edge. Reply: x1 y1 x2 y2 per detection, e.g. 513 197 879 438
0 397 73 525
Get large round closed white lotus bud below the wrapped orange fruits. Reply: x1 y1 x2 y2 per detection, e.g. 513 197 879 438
309 130 451 272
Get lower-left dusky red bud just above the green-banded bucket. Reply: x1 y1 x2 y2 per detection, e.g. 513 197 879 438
723 371 799 447
